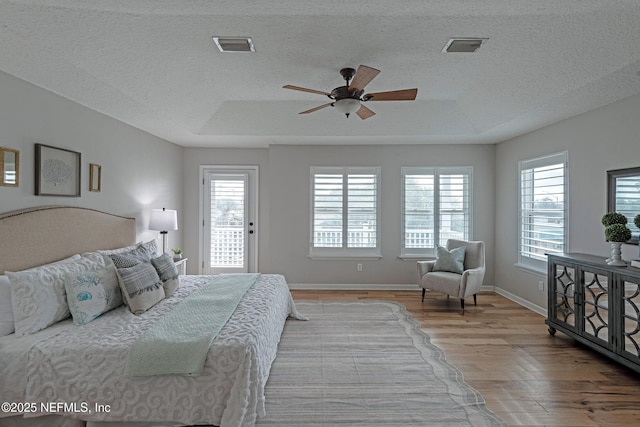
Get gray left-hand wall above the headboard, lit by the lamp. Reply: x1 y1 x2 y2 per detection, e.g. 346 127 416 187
0 72 184 247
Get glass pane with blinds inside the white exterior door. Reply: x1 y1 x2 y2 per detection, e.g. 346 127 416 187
209 178 245 268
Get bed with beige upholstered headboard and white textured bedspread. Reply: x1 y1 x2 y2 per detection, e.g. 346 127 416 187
0 207 301 427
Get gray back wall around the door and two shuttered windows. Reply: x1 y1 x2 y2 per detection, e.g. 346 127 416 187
184 144 495 285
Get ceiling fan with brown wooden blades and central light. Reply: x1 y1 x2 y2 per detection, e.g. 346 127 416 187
282 65 418 120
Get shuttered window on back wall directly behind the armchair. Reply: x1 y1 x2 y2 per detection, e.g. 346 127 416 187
400 167 472 257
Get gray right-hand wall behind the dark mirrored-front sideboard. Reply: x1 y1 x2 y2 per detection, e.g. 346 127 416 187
495 96 640 308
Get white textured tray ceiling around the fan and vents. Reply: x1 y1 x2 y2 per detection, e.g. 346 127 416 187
0 0 640 147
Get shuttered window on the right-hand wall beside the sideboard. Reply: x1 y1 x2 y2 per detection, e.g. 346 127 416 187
518 152 568 270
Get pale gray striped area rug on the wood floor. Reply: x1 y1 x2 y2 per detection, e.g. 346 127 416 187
256 301 507 427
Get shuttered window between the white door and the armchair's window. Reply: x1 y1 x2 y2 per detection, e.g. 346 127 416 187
310 167 380 257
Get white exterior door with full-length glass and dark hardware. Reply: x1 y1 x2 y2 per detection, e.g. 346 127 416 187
202 166 258 274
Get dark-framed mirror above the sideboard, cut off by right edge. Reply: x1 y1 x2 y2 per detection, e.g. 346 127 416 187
607 167 640 245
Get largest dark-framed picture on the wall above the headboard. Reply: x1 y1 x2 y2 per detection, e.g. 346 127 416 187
36 144 80 197
